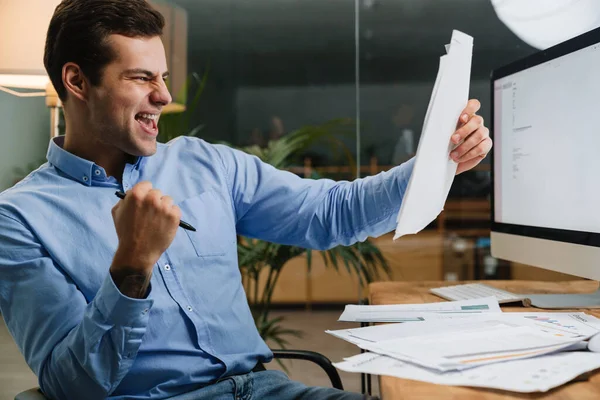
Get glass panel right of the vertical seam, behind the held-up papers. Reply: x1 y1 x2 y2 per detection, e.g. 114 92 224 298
358 0 536 280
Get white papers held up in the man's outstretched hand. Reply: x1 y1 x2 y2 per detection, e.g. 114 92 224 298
394 30 473 239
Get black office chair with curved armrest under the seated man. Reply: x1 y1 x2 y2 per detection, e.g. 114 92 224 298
15 350 344 400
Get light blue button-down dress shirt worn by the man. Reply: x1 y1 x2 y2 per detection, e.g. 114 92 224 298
0 137 413 400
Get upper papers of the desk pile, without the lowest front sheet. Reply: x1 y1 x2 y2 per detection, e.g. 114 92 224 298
327 313 598 371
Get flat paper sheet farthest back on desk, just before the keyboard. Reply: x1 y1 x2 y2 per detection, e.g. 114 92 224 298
338 297 502 322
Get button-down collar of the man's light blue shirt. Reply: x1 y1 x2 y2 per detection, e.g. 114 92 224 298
46 136 147 186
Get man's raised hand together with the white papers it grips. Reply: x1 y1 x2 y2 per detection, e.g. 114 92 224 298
394 31 492 239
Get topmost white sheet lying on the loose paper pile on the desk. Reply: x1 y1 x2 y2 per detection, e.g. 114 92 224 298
362 326 581 371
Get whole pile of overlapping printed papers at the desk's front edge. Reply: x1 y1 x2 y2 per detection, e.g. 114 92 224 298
327 303 600 392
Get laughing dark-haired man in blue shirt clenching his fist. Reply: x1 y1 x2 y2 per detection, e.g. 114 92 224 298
0 0 491 399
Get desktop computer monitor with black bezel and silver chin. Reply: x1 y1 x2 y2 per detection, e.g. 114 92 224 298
490 28 600 308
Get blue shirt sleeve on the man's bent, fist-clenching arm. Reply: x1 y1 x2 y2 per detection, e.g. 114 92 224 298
0 213 153 399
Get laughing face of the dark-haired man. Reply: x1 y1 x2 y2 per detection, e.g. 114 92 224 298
88 35 171 156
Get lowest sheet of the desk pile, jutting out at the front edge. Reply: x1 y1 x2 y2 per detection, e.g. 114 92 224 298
333 352 600 393
